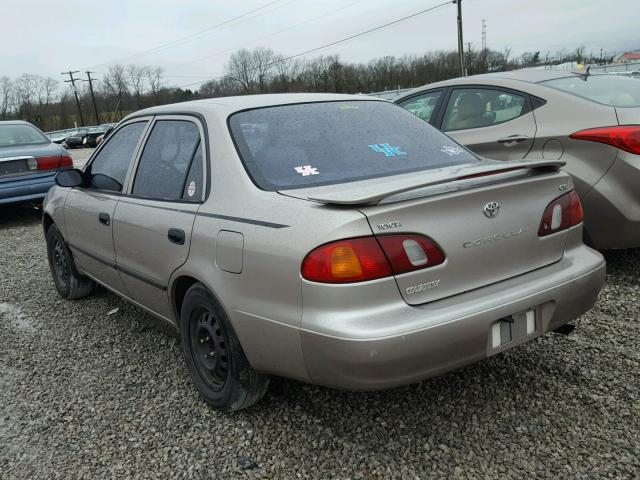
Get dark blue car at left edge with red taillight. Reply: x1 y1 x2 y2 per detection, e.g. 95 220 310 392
0 120 73 204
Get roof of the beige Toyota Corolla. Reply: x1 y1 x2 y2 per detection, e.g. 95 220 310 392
125 93 386 120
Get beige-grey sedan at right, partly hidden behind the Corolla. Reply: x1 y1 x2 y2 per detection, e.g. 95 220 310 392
395 70 640 249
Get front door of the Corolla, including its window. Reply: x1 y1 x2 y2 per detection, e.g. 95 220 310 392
64 118 149 295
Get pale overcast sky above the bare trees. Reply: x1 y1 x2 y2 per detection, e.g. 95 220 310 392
0 0 640 88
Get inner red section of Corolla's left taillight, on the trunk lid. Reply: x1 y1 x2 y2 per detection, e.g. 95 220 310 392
378 235 445 275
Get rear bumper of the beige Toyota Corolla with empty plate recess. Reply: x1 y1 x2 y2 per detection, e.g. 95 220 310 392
301 236 605 390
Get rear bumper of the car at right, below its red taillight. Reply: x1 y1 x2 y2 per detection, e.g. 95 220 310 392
582 152 640 250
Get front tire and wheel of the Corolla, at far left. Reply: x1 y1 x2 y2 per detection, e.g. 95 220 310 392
47 224 95 300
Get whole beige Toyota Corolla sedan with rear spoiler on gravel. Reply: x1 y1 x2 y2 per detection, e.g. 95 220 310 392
43 94 605 410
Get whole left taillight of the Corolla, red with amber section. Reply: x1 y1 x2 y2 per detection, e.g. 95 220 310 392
301 235 445 283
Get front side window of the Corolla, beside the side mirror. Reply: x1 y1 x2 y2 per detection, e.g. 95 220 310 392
86 122 147 192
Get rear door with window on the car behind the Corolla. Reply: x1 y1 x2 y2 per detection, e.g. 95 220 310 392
440 86 536 160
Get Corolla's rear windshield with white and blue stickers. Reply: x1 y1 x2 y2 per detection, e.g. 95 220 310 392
229 101 478 190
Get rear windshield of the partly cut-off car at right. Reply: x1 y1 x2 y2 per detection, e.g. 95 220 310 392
540 74 640 107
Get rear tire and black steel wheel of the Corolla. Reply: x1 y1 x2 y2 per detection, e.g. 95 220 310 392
180 283 269 412
